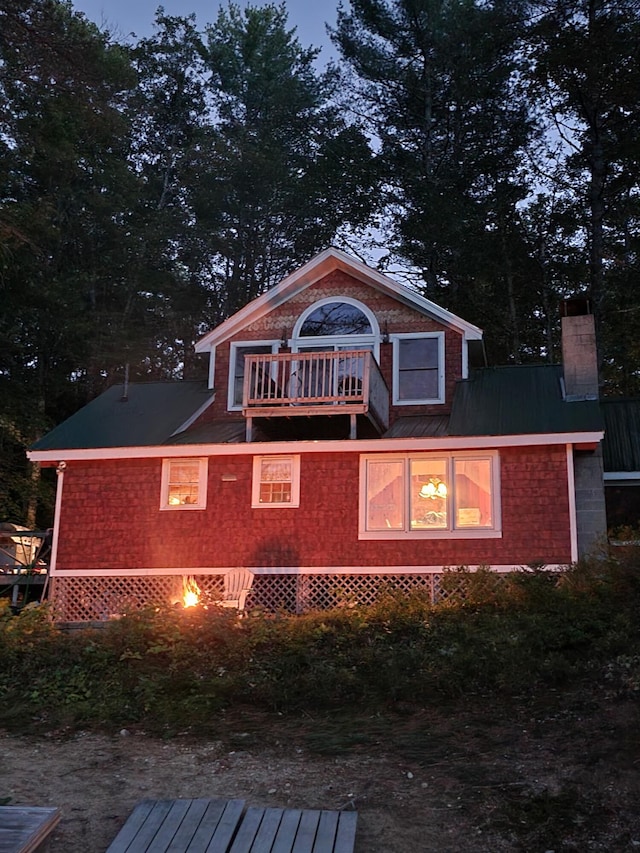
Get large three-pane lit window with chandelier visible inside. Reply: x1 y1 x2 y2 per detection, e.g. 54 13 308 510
359 451 502 539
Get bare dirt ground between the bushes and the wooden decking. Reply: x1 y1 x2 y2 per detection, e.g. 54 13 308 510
0 696 640 853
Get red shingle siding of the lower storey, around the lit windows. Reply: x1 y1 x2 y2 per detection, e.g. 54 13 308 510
58 447 571 573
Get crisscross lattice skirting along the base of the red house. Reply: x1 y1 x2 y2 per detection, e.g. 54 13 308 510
49 573 463 622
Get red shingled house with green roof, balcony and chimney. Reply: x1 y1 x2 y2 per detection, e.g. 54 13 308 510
29 249 606 621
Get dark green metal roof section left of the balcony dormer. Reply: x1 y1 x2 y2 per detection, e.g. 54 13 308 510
31 381 213 450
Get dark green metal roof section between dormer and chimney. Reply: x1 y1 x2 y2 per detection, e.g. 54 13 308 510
449 364 604 436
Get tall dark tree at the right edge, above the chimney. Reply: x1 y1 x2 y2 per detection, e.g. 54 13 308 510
529 0 640 393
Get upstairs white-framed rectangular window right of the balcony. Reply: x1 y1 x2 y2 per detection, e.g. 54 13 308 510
391 332 444 406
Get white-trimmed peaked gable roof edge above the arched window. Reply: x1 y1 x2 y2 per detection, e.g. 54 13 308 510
195 246 482 352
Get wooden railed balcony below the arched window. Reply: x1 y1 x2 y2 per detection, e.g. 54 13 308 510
242 350 389 441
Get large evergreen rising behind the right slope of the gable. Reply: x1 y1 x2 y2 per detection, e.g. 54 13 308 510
333 0 532 358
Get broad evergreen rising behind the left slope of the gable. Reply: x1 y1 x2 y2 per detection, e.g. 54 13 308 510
196 4 380 319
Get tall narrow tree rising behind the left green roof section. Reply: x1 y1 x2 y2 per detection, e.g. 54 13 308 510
129 10 211 377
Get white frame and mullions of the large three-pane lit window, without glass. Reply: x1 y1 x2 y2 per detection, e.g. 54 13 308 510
358 450 502 540
